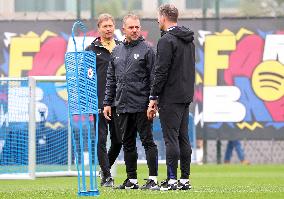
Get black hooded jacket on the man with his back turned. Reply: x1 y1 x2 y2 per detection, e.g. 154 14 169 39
151 26 195 104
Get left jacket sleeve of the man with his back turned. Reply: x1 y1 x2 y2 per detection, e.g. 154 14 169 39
150 37 173 96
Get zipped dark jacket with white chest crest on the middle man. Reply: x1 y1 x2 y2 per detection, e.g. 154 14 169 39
104 37 155 113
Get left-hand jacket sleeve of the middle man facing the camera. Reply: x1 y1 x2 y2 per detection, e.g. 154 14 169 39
103 55 116 106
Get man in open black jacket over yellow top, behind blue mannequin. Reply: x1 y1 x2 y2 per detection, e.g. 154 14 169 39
86 14 122 187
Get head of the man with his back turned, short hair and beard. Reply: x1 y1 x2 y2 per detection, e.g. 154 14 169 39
158 4 178 31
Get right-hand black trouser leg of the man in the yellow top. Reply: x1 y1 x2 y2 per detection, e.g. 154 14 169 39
108 108 122 168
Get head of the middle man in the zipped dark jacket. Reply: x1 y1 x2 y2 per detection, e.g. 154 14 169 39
122 14 141 42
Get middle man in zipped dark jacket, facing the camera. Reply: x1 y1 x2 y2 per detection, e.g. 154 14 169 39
104 14 158 189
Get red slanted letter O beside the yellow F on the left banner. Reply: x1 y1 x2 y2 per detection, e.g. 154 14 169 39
29 37 67 76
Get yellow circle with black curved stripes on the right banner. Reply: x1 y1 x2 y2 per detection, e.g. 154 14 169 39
252 61 284 101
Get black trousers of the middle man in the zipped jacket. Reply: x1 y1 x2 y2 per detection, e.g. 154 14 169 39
117 112 158 179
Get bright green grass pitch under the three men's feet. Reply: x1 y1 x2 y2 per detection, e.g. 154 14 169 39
0 165 284 199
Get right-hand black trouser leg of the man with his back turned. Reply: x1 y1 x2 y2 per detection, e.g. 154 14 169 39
179 104 192 179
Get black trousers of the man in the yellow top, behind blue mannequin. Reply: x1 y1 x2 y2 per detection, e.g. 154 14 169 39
98 108 122 178
